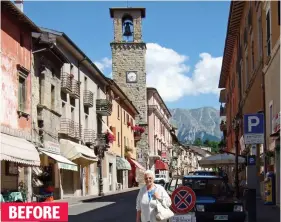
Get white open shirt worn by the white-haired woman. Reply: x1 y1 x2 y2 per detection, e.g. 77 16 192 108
136 184 172 222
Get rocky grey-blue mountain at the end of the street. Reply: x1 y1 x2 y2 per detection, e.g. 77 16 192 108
170 107 222 144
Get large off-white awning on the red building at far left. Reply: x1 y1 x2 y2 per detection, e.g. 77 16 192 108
0 133 40 166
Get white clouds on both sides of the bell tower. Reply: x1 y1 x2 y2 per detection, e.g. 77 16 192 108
95 43 222 102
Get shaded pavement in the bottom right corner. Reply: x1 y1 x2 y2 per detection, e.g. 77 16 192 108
256 199 280 222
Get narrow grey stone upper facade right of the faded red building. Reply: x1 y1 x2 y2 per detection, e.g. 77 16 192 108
32 52 62 143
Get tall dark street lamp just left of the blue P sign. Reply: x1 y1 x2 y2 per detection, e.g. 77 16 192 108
232 115 240 198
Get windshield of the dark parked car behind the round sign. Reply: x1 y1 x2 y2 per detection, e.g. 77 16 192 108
183 178 230 197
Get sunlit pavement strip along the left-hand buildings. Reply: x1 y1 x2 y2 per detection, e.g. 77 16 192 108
54 187 140 206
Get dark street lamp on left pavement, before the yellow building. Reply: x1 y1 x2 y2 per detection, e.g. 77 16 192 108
95 138 108 196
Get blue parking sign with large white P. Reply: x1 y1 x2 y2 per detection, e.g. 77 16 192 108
244 113 264 144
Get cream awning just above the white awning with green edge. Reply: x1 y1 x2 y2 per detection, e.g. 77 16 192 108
60 139 98 166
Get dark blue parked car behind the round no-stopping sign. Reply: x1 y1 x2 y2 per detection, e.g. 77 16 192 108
166 175 246 222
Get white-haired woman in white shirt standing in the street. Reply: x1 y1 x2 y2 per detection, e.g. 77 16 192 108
136 170 171 222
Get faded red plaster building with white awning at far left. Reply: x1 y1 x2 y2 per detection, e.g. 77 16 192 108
0 1 40 201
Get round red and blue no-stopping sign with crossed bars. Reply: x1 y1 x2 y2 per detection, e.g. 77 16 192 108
171 186 196 214
